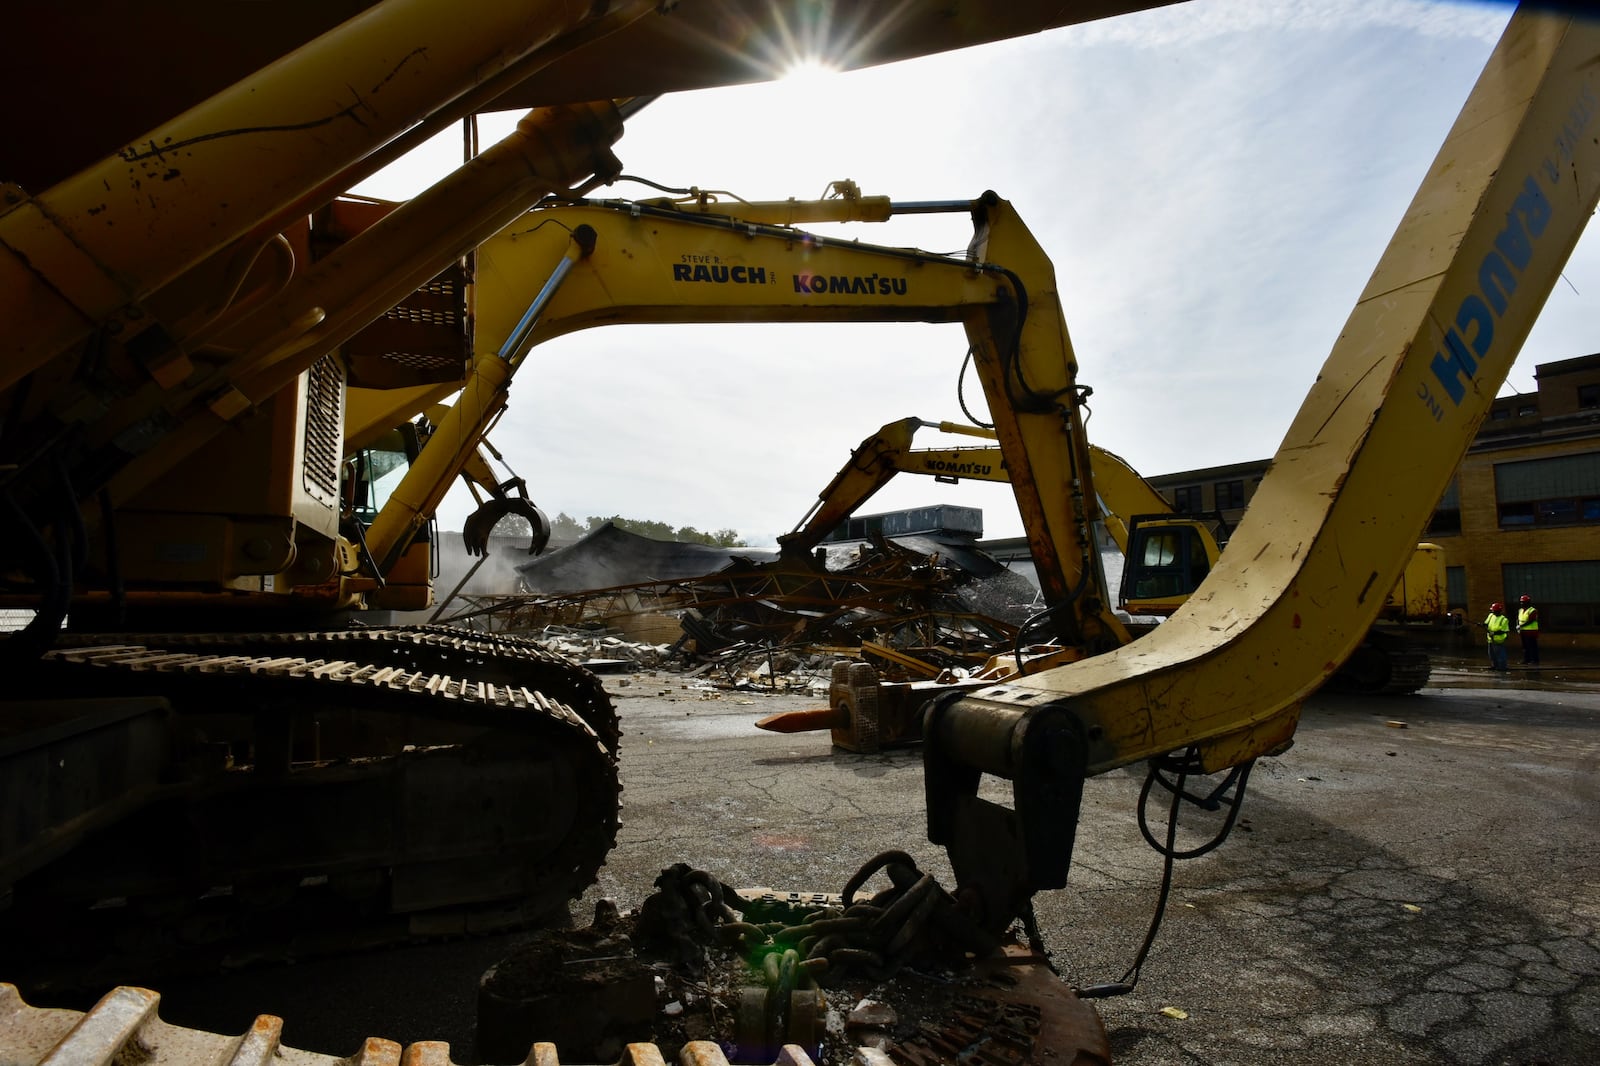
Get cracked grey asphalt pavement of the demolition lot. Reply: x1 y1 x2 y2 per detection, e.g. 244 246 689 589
50 663 1600 1066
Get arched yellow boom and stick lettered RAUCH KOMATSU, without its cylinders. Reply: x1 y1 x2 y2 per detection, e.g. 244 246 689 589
382 194 1128 650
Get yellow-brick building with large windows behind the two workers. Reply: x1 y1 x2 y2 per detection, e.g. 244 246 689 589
1147 354 1600 647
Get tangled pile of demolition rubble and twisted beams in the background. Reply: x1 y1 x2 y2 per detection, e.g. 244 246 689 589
448 523 1034 690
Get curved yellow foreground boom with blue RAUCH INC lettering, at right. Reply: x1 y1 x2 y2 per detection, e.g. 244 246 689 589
925 8 1600 920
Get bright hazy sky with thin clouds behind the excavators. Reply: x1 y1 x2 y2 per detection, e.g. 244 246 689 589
350 0 1600 544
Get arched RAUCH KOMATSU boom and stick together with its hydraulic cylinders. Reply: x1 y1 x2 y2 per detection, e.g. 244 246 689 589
328 182 1152 771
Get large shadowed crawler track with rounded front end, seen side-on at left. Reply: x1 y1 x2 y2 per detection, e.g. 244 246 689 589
0 631 619 983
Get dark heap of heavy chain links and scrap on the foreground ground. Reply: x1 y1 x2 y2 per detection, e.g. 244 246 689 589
477 852 1109 1066
